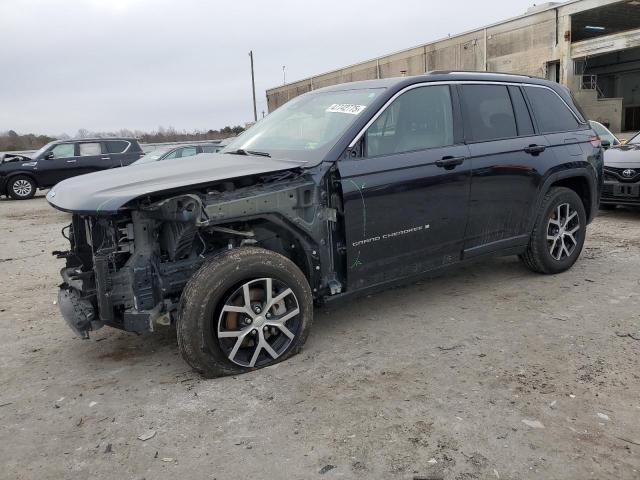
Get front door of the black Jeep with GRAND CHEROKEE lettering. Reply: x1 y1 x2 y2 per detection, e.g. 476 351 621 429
338 85 471 289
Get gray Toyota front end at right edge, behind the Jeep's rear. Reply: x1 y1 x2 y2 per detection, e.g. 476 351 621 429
600 129 640 209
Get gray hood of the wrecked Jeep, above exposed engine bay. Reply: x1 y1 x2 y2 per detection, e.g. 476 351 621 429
47 153 304 214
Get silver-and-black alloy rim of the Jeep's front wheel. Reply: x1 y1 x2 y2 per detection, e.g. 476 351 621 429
217 278 300 368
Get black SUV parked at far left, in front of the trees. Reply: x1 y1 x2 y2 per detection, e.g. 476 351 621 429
0 138 142 200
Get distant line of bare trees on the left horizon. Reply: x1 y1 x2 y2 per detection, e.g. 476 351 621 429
0 125 244 152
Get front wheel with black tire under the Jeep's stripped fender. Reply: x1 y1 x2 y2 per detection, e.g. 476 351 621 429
176 247 313 378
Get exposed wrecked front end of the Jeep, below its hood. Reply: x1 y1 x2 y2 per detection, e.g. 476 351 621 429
54 172 339 338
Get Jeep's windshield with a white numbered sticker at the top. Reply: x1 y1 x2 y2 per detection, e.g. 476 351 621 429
221 88 383 162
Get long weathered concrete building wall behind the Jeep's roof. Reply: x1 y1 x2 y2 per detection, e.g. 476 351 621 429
267 0 640 131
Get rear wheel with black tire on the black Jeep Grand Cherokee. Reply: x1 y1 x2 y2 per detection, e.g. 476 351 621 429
520 187 587 274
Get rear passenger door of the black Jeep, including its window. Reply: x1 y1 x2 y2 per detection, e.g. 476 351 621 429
459 84 554 257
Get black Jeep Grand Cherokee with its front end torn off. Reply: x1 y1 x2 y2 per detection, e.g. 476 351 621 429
47 72 602 376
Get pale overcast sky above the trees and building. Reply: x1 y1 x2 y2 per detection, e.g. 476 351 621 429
0 0 533 135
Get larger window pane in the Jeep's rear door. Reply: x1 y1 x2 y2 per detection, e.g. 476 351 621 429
462 85 518 142
